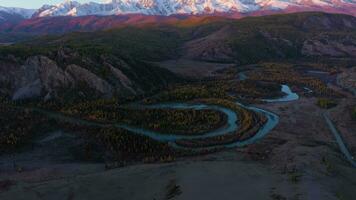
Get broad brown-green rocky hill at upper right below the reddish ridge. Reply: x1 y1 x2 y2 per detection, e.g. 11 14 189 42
183 13 356 64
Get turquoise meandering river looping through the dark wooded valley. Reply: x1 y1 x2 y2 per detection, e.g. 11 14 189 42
35 85 299 148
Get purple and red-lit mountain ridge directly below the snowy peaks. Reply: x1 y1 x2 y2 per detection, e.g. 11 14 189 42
0 12 354 35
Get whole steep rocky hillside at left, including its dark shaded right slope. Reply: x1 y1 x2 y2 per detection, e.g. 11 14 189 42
0 48 178 100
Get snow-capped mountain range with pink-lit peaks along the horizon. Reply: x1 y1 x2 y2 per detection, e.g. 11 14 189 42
33 0 356 17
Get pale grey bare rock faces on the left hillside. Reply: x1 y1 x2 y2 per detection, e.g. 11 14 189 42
0 56 113 100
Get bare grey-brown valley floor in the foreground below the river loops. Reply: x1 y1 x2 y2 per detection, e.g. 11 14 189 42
0 97 356 200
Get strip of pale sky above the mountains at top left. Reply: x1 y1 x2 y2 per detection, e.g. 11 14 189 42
0 0 104 8
